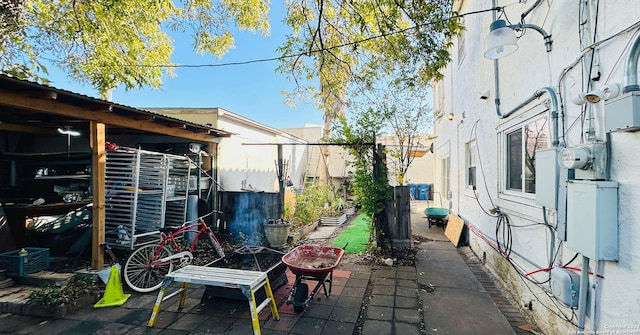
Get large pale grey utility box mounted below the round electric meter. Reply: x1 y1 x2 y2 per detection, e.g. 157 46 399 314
567 180 618 261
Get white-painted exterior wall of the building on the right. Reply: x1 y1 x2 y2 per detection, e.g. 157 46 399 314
433 0 640 334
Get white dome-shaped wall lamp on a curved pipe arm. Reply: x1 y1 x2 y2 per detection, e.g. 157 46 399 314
484 20 553 59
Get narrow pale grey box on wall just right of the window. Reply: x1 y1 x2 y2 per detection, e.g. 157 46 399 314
536 148 560 209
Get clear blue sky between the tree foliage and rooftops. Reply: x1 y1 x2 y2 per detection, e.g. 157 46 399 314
48 1 323 128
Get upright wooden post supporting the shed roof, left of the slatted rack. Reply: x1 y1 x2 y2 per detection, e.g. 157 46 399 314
90 121 107 269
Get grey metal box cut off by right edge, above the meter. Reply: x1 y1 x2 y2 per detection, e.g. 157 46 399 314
604 91 640 132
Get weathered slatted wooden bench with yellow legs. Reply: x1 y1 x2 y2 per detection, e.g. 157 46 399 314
148 265 280 335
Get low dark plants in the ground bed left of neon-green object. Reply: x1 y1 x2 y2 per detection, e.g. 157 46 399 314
27 277 104 306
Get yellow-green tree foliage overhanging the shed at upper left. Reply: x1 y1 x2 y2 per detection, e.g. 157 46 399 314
0 0 270 96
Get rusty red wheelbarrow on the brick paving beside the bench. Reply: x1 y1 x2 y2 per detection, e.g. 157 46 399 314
282 245 347 313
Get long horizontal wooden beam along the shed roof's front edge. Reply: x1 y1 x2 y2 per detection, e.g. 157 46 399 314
0 90 217 142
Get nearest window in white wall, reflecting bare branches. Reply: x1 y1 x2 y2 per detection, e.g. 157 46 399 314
505 118 549 194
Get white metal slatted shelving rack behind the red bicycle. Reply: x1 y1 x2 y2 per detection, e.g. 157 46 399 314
105 148 191 250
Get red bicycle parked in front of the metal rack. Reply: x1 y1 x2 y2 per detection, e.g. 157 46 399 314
122 219 225 293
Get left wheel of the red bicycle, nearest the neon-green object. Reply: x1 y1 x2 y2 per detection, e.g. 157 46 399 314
122 244 173 293
